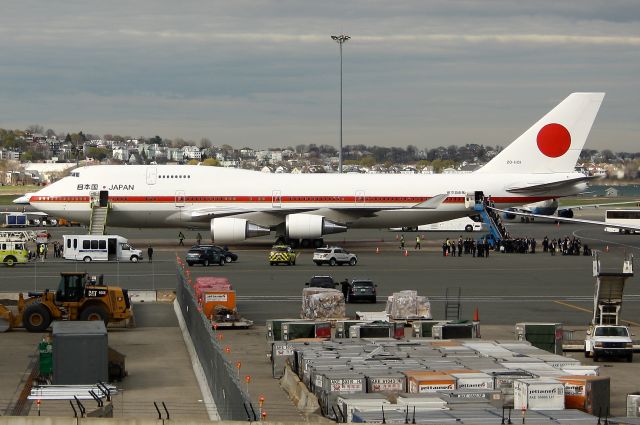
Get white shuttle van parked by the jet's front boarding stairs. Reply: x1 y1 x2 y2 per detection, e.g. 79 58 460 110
62 235 142 263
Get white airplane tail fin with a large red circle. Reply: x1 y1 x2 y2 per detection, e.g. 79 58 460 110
476 93 604 174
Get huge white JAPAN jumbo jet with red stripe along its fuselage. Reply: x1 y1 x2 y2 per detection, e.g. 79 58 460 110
14 93 604 245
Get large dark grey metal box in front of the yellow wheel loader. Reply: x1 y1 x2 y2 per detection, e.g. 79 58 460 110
52 320 109 385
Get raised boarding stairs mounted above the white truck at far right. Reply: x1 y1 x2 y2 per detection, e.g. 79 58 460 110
591 252 633 325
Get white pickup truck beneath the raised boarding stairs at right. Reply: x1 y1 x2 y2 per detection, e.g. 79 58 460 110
584 325 633 363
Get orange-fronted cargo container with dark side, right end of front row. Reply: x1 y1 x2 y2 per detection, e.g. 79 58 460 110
558 375 611 416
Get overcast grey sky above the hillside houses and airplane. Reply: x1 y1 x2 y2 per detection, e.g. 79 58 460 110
0 0 640 152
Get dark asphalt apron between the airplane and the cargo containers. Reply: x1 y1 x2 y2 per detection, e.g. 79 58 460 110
0 210 640 326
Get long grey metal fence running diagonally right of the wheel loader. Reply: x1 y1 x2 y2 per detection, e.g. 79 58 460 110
176 259 259 421
